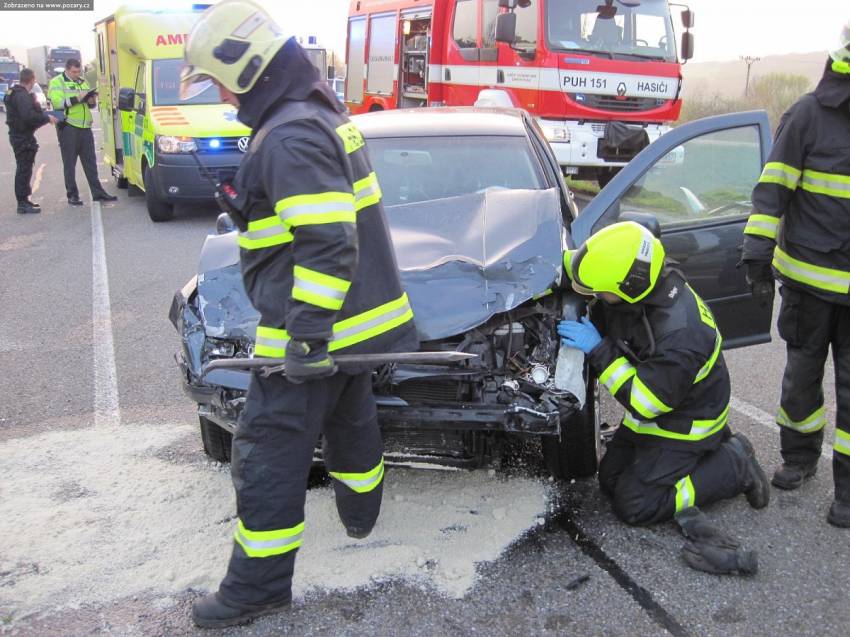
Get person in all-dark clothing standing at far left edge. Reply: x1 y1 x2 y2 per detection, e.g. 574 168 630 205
3 69 56 215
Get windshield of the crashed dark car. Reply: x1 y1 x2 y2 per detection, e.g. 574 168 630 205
368 136 546 206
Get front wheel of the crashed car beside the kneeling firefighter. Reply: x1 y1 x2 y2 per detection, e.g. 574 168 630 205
543 380 602 480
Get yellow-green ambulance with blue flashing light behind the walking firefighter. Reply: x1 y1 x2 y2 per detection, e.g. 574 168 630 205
95 5 250 221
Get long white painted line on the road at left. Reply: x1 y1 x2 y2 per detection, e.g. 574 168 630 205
91 201 121 427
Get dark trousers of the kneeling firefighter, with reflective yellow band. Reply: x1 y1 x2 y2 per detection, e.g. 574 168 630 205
599 425 746 525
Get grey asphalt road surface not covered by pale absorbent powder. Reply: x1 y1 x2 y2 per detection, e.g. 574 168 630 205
0 120 850 636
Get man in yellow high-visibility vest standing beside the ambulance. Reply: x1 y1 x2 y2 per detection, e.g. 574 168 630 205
47 58 118 206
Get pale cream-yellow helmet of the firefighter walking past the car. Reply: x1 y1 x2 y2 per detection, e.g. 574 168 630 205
180 0 289 100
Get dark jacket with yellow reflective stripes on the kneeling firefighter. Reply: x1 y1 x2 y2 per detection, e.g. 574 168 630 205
588 271 731 448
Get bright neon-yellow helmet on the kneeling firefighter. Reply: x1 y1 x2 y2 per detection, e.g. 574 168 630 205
564 221 664 303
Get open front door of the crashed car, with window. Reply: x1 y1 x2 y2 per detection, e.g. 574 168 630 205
571 111 773 349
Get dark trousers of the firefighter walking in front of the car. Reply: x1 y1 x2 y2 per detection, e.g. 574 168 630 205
219 372 384 608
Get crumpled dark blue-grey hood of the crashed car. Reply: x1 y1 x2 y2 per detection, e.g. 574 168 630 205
193 189 564 341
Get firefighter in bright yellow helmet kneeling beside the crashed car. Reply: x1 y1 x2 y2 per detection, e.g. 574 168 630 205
558 222 770 573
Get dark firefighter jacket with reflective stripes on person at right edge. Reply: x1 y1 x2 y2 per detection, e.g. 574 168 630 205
743 64 850 305
